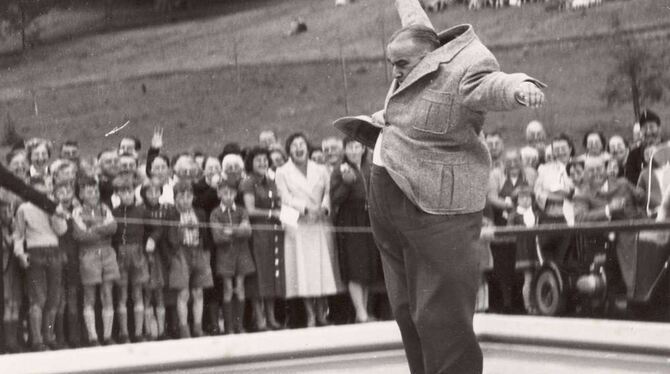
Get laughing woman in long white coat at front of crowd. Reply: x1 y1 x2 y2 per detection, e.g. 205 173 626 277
276 133 342 326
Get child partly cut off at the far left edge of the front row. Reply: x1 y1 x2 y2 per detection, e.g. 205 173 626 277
0 199 23 353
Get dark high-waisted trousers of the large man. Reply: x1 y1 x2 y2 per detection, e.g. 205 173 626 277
369 166 482 374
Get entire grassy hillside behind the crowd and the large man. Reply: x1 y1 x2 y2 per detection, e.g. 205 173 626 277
0 0 670 153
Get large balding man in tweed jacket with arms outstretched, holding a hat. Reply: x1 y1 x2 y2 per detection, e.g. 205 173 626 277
346 0 544 374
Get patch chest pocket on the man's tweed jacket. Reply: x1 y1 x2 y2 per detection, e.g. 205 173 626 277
412 89 454 134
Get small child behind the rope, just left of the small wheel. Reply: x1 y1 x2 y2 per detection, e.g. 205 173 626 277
507 186 539 314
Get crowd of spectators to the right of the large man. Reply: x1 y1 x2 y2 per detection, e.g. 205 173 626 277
481 110 670 314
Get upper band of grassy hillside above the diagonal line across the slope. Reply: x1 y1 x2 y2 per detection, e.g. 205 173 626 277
0 0 670 99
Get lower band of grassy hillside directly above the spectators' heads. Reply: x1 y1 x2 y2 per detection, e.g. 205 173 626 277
0 35 670 156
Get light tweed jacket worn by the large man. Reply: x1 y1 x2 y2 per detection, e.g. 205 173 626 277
381 25 543 214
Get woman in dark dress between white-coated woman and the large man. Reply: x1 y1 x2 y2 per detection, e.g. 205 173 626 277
330 138 381 322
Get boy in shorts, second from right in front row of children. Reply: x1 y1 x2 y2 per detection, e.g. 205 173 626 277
168 180 214 338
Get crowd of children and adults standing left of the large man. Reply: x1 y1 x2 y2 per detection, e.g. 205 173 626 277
0 129 390 353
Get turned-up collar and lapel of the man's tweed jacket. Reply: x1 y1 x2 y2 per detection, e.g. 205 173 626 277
393 24 477 95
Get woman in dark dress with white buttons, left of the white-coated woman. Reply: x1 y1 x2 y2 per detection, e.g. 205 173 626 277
240 147 284 330
